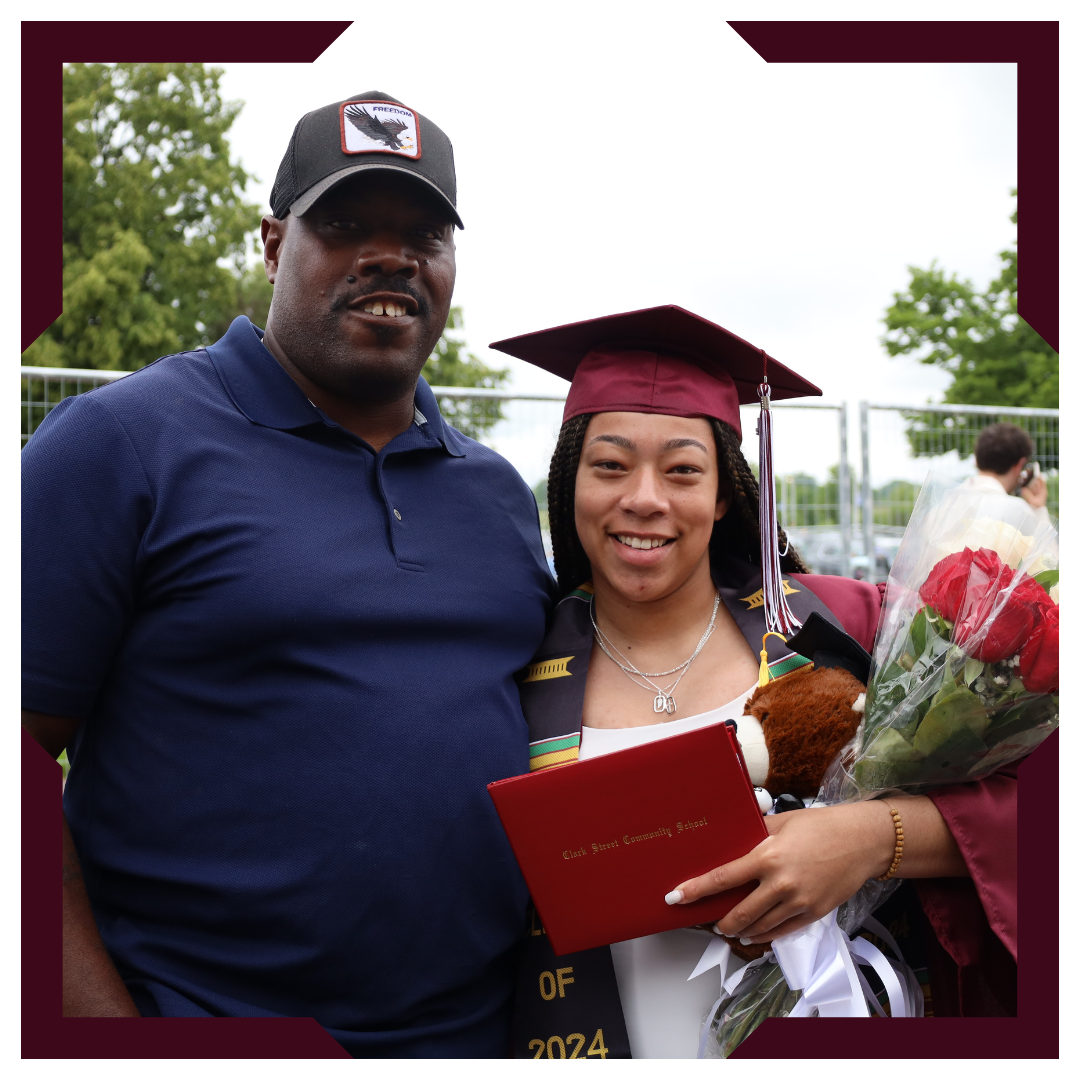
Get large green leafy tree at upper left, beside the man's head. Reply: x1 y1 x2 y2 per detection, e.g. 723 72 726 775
23 64 261 370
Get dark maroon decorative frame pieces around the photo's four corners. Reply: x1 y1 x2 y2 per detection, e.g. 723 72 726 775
22 22 1058 1059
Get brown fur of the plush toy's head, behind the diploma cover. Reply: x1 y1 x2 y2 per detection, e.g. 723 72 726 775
743 665 866 799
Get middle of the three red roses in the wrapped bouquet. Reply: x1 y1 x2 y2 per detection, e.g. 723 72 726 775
953 548 1028 664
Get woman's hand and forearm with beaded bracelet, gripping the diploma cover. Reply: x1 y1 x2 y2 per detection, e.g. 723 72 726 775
669 795 968 944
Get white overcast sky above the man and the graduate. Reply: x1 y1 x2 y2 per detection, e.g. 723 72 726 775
208 22 1016 486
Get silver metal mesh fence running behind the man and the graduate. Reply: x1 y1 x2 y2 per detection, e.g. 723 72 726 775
22 367 1058 581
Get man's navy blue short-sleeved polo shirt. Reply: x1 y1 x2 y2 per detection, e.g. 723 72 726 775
23 319 551 1057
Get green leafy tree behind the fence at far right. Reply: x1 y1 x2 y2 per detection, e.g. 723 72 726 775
881 188 1058 464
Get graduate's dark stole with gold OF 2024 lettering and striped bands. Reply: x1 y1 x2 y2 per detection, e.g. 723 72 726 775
513 558 842 1059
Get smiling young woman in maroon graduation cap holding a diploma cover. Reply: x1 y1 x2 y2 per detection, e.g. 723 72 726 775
498 308 1015 1057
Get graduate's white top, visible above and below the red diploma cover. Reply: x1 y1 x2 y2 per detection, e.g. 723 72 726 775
578 687 756 1058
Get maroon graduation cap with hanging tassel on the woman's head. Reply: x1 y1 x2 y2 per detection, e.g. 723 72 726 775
490 303 821 635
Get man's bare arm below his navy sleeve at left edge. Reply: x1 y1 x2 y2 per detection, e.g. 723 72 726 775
23 708 139 1016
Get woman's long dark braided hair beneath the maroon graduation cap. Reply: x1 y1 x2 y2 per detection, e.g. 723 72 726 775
548 414 810 596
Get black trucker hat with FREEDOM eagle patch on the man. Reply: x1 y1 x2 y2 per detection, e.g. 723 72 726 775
270 90 464 229
